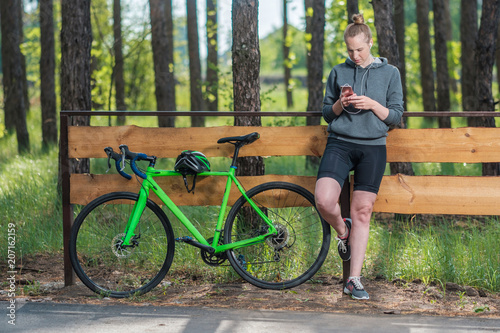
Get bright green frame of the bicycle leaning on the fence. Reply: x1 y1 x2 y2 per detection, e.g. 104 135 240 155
123 166 277 253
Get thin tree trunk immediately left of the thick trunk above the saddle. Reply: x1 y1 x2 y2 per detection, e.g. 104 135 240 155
205 0 219 111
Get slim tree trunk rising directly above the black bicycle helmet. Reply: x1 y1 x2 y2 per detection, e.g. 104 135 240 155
187 0 205 127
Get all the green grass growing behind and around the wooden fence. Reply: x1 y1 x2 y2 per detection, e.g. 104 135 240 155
0 105 500 292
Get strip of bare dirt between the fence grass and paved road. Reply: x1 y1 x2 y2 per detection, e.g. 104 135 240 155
0 256 500 318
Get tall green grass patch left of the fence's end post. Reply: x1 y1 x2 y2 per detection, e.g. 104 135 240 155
0 140 62 254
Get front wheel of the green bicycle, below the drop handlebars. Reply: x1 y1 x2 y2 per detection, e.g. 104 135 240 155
69 192 175 297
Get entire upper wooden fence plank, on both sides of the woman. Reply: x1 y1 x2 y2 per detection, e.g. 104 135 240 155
68 126 500 163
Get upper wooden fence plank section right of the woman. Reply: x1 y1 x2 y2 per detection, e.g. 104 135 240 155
387 127 500 163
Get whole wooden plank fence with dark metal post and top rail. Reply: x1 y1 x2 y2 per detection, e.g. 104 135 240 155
61 111 500 285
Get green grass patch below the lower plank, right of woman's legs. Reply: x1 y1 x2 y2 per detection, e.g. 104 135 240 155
364 217 500 291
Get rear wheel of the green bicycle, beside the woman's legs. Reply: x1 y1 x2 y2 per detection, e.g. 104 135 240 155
224 182 330 289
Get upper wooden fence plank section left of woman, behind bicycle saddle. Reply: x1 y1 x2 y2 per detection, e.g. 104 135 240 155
68 126 327 158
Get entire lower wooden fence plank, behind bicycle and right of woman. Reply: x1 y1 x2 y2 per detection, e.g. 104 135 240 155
71 174 500 215
